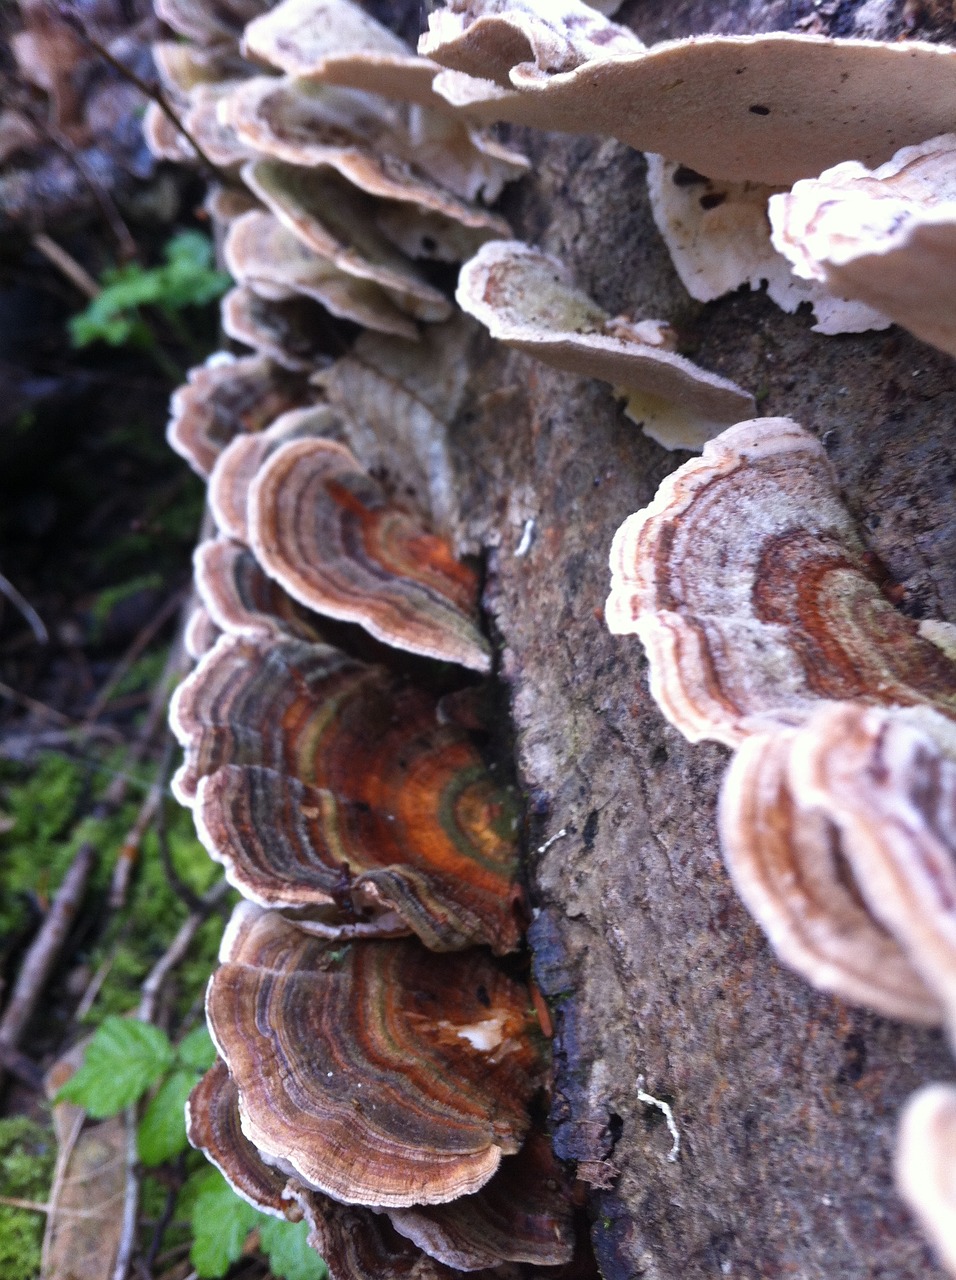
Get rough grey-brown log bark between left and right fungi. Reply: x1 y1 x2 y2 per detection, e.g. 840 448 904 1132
445 0 956 1280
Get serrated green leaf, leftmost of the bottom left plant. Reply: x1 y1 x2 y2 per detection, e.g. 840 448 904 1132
56 1014 173 1119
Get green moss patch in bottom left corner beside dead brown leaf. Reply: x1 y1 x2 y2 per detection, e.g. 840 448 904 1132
0 1116 56 1280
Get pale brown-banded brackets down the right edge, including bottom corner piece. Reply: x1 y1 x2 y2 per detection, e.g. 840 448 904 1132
607 419 956 1265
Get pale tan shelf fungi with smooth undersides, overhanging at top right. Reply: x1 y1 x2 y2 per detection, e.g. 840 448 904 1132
420 0 956 353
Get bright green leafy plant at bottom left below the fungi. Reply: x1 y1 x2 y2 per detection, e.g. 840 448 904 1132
58 1016 326 1280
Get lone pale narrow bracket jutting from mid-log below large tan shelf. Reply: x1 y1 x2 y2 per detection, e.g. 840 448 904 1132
456 241 755 449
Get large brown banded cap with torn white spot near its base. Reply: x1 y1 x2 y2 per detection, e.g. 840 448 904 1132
206 904 541 1207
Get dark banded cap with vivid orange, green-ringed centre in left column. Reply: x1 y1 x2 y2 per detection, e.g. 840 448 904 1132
174 629 521 952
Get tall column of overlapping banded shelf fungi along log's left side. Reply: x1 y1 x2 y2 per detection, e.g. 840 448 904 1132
147 0 598 1280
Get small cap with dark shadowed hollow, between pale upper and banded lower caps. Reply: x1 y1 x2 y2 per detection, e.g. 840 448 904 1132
219 284 340 372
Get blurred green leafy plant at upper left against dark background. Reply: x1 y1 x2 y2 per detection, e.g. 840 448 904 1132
69 230 232 376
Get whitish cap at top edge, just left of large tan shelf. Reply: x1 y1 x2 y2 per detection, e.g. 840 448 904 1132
243 0 440 105
